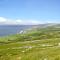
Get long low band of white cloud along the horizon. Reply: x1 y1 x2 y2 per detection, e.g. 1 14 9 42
0 17 59 25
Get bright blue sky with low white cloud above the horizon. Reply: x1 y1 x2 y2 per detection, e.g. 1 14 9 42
0 0 60 25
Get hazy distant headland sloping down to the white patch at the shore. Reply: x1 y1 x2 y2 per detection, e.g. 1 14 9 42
19 23 60 34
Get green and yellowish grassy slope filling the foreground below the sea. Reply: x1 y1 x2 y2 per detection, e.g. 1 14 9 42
0 27 60 60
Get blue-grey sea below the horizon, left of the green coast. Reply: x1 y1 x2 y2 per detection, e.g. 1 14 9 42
0 25 31 37
